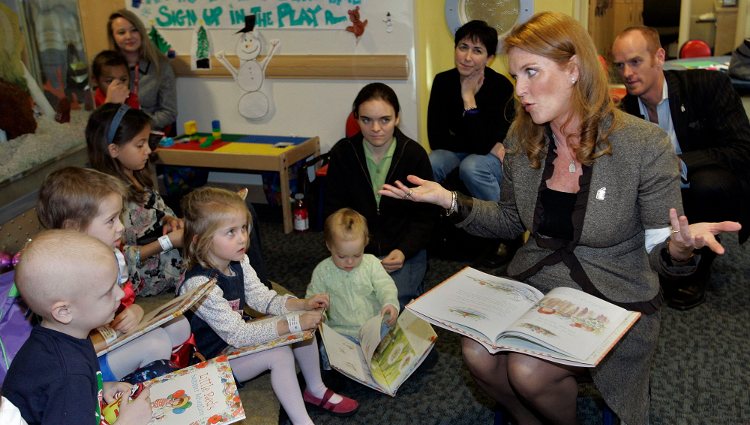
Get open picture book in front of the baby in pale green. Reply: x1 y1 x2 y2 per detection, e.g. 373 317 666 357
320 310 437 396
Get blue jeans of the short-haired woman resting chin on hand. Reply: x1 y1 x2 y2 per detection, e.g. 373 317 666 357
430 149 503 202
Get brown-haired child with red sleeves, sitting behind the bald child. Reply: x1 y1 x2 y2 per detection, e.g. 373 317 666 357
36 167 190 381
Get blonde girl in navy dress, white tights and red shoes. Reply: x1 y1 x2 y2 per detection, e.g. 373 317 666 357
179 188 359 424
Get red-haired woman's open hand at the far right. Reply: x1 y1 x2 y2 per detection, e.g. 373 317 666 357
669 208 742 260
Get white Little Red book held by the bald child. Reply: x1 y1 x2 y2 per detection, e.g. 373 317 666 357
102 356 245 425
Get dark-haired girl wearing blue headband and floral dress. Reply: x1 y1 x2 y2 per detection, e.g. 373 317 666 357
86 103 182 295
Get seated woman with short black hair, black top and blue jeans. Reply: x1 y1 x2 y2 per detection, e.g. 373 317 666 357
427 21 513 201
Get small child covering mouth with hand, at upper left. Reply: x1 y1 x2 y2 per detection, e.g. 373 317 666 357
91 50 140 109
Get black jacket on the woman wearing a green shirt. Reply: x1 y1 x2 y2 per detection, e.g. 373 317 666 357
323 128 440 259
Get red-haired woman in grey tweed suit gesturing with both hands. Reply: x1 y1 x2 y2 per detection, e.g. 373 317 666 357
381 12 740 425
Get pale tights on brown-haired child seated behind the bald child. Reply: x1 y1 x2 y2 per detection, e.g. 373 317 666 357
107 316 190 380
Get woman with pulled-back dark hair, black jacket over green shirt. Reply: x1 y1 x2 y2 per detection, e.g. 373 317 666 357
324 83 437 308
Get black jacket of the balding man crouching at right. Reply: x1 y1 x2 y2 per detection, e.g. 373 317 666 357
622 70 750 241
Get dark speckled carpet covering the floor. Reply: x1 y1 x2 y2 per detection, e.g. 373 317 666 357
254 213 750 425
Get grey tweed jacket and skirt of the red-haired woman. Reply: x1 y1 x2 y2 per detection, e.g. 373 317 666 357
457 111 695 425
